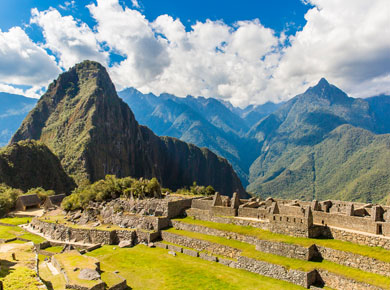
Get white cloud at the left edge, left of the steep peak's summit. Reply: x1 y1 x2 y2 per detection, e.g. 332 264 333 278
0 27 60 86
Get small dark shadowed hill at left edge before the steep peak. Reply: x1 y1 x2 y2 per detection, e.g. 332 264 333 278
0 141 76 193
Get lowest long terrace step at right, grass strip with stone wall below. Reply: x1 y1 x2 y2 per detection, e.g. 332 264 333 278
162 229 390 290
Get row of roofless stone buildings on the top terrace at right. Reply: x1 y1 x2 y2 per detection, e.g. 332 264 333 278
187 193 390 245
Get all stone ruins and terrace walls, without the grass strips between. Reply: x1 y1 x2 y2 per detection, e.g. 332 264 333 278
32 193 390 290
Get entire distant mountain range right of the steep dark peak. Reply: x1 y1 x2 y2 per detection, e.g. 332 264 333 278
1 64 390 202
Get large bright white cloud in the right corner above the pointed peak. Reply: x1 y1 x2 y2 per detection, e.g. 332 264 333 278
269 0 390 98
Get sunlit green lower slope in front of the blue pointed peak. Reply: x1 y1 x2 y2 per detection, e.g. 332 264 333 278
249 125 390 202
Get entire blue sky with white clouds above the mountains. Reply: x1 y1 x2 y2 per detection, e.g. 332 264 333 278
0 0 390 107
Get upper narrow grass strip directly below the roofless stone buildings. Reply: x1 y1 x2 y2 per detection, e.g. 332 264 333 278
176 217 390 263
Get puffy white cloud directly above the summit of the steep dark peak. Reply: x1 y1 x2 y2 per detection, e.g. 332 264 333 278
31 8 108 69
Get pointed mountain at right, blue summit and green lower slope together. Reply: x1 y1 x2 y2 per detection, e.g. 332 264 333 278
248 79 390 201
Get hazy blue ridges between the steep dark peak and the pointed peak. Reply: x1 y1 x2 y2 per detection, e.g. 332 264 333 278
119 88 278 185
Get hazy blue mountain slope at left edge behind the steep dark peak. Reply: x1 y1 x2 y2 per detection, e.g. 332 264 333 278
0 92 37 147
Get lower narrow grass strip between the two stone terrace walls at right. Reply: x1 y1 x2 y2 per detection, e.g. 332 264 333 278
166 228 390 289
